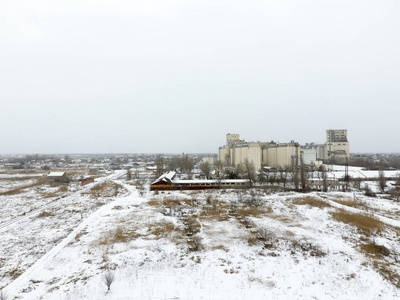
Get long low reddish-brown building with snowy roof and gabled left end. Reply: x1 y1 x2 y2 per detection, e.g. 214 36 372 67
150 171 250 191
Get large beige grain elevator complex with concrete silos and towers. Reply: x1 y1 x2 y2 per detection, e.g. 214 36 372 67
218 129 350 170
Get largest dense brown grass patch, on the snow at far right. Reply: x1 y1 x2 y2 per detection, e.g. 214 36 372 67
331 209 385 236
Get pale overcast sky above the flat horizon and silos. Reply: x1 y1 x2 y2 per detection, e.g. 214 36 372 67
0 0 400 154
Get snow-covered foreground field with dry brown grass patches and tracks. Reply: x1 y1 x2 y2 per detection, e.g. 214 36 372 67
0 172 400 299
